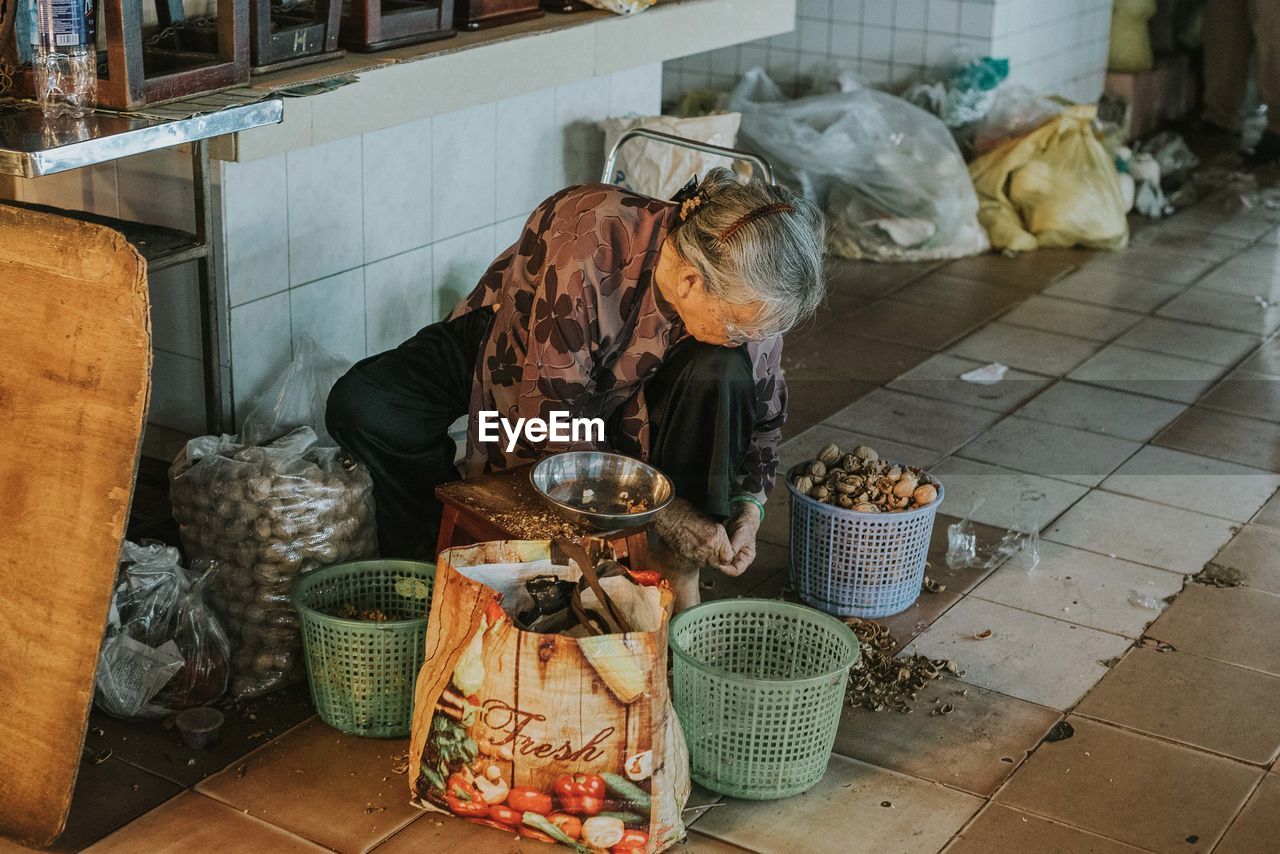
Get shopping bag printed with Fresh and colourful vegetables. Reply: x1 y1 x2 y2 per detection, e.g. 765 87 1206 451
412 543 689 854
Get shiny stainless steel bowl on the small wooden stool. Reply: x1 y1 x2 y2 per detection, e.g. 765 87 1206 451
529 451 675 531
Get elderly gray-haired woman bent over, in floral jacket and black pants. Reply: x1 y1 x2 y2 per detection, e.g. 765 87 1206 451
328 169 823 607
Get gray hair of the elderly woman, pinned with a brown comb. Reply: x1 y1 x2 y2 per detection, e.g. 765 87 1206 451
671 168 826 338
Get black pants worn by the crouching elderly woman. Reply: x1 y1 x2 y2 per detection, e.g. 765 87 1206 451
325 311 755 558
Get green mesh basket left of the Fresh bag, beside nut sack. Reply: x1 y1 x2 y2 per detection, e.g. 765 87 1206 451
292 561 435 737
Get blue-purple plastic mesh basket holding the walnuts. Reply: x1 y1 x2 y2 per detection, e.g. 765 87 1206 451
787 468 943 617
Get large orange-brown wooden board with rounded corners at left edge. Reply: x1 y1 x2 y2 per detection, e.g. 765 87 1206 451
0 205 151 845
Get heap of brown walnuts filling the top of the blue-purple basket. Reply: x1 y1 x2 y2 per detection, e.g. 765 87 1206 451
788 444 938 513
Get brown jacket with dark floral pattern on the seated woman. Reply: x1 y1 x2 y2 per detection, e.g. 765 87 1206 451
451 184 787 502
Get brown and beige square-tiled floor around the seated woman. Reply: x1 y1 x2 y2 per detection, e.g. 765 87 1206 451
15 165 1280 854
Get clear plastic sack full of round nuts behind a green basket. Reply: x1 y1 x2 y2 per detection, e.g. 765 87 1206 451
169 426 378 697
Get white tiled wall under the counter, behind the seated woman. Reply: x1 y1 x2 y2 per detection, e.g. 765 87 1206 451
13 64 662 433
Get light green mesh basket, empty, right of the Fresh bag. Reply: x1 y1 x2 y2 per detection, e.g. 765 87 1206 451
671 599 858 800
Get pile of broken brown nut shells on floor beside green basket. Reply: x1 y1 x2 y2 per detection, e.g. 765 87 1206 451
845 617 964 716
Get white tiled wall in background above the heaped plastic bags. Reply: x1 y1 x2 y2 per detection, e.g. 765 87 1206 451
663 0 1111 101
